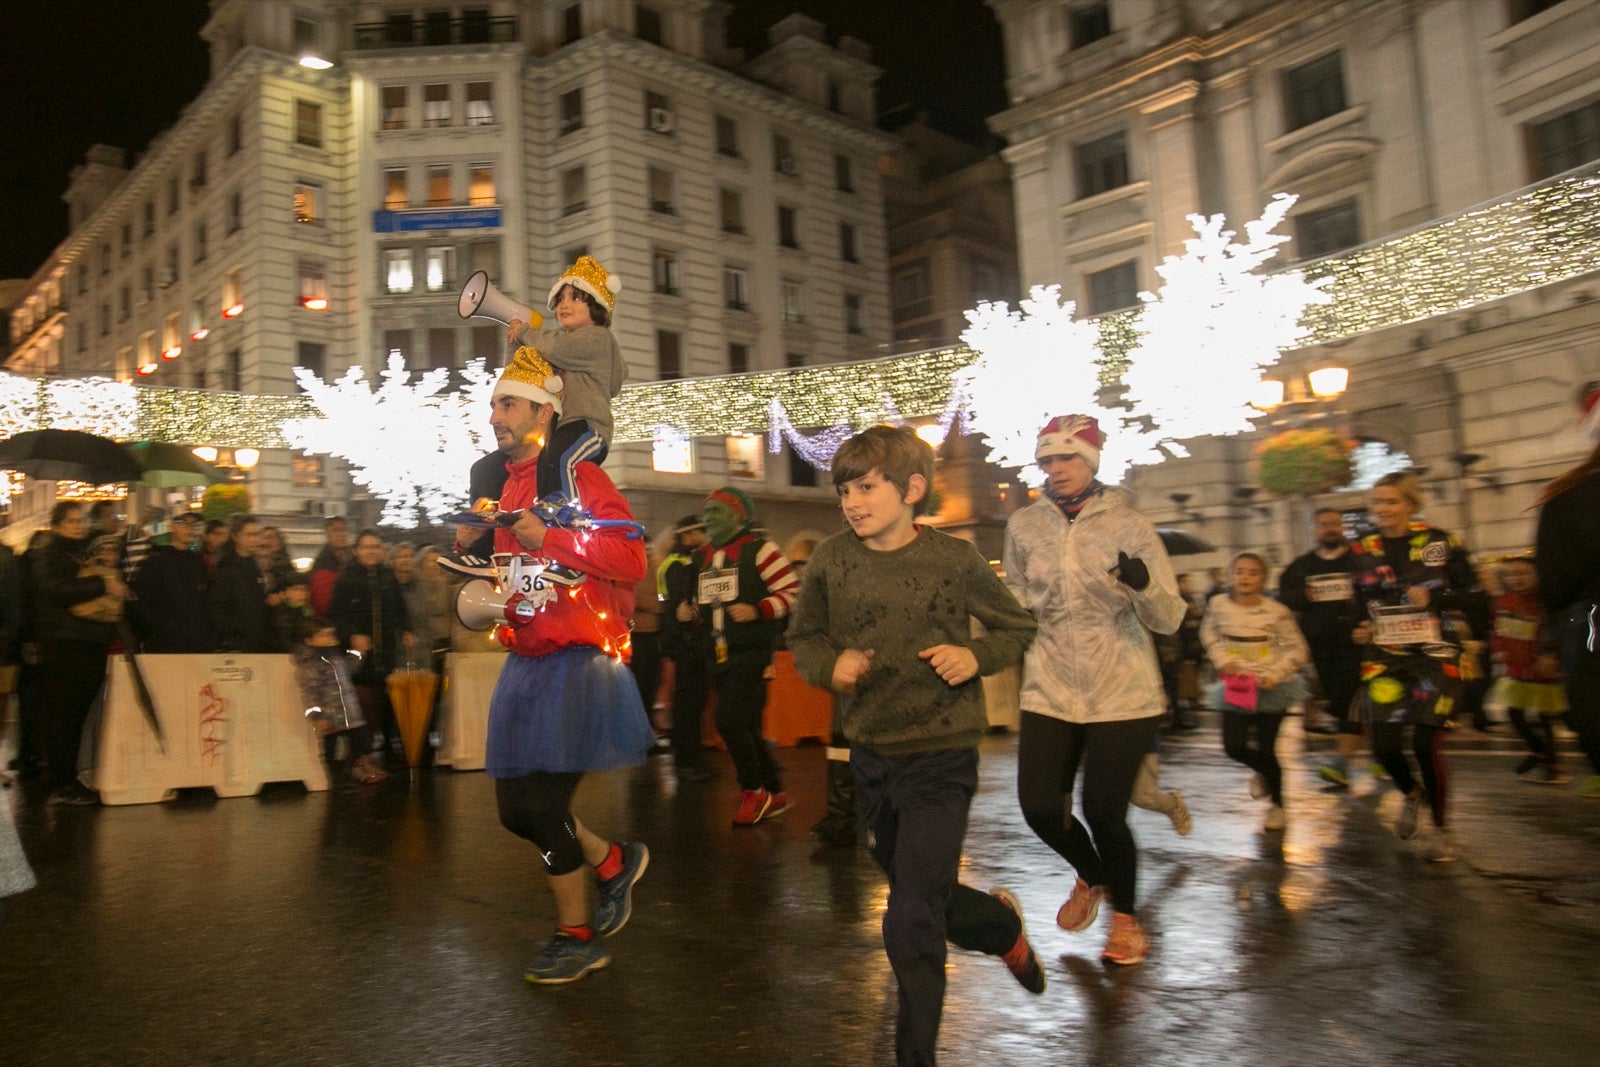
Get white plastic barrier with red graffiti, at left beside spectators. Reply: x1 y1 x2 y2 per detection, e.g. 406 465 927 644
93 656 328 805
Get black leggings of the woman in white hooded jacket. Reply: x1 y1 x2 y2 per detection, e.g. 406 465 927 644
1016 712 1162 915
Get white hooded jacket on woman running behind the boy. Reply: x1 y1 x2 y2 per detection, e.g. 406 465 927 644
1005 488 1187 723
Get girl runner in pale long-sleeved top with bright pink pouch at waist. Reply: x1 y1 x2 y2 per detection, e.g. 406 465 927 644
1200 552 1310 830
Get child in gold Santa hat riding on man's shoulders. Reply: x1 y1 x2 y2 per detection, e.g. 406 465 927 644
507 256 627 506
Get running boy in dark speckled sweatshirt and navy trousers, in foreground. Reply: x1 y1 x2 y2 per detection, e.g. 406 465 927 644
787 426 1045 1064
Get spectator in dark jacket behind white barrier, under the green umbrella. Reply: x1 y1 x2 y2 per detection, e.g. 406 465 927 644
128 512 216 654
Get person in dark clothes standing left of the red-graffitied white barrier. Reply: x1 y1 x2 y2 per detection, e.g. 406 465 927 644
34 501 128 805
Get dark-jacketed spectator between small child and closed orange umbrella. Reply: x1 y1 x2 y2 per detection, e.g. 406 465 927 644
330 530 416 747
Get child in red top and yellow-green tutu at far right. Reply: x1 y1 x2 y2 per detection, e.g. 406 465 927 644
1490 560 1570 785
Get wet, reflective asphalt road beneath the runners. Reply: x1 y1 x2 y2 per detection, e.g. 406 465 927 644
0 721 1600 1067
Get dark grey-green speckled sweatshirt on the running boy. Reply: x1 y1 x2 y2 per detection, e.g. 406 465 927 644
784 526 1038 755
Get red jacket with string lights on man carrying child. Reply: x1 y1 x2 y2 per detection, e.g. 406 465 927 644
494 458 648 662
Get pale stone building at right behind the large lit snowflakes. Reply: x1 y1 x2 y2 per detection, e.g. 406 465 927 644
989 0 1600 561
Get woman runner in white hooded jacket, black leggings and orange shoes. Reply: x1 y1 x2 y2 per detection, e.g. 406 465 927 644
1005 416 1186 965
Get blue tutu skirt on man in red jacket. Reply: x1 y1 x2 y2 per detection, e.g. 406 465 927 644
485 645 656 777
